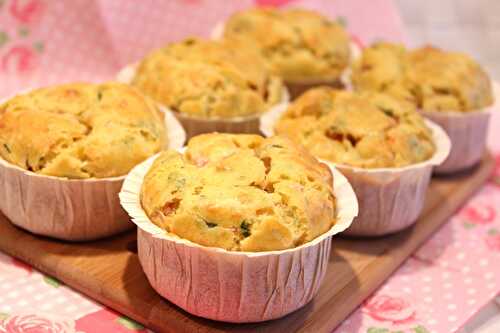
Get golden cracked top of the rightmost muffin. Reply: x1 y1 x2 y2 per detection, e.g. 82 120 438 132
352 43 493 112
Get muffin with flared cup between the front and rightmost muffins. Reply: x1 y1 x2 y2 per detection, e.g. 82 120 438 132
263 87 449 236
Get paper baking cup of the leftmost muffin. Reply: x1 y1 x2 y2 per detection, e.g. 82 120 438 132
0 95 185 241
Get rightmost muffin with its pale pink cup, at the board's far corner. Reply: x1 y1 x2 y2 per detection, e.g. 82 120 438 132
352 43 493 173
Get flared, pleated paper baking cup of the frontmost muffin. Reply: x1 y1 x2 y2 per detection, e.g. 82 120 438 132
120 151 358 323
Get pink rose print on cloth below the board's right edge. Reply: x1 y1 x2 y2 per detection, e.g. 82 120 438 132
362 295 416 325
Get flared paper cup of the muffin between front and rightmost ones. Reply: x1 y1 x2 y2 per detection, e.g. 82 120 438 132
261 107 451 236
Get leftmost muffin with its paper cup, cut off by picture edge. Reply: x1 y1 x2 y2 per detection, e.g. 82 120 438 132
0 83 184 240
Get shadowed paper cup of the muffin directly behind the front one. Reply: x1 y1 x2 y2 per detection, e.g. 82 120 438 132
116 64 290 140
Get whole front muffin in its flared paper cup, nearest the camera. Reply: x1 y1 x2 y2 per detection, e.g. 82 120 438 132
120 133 357 322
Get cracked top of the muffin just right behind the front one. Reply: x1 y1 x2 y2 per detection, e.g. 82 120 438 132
275 87 435 168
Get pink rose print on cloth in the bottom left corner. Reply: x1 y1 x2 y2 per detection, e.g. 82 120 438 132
0 314 77 333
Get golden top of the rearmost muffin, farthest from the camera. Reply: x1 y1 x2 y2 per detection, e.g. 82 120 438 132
224 7 350 83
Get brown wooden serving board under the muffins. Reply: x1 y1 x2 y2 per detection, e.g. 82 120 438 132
0 154 494 333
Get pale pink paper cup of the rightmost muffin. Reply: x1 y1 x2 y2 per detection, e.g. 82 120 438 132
421 108 491 174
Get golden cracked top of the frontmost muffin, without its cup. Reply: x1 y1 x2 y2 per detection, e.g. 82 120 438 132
141 133 335 252
